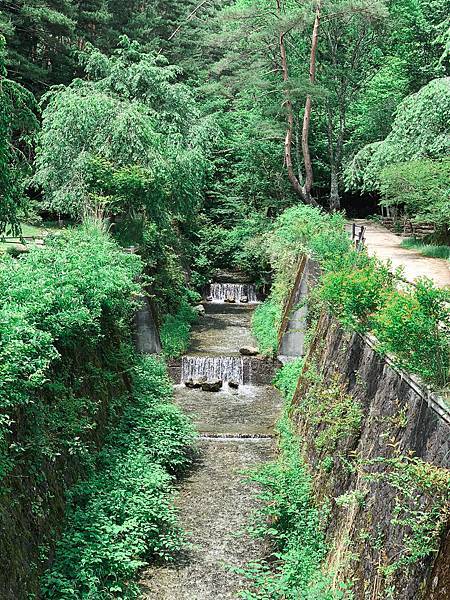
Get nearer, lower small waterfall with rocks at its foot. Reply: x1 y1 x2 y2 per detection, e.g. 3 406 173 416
181 356 244 385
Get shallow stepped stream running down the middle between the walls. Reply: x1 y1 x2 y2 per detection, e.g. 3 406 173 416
141 282 281 600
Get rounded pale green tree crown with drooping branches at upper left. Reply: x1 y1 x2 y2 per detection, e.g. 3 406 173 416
34 38 213 220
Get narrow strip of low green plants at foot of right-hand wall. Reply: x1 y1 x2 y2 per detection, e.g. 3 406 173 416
240 416 349 600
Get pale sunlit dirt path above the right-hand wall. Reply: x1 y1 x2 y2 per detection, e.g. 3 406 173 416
356 220 450 287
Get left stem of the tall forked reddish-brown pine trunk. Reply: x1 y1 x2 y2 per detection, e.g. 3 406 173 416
277 0 317 206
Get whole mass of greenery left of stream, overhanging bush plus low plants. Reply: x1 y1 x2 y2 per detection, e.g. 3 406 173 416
0 223 199 598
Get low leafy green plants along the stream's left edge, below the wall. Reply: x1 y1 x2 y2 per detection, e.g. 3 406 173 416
42 357 195 600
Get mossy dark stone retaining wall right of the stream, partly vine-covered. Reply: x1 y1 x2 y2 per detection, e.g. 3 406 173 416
280 256 450 600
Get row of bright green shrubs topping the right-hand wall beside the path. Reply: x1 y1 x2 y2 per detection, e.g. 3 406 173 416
253 207 450 387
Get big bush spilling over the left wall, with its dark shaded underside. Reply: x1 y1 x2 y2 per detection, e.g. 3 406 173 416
0 224 146 595
